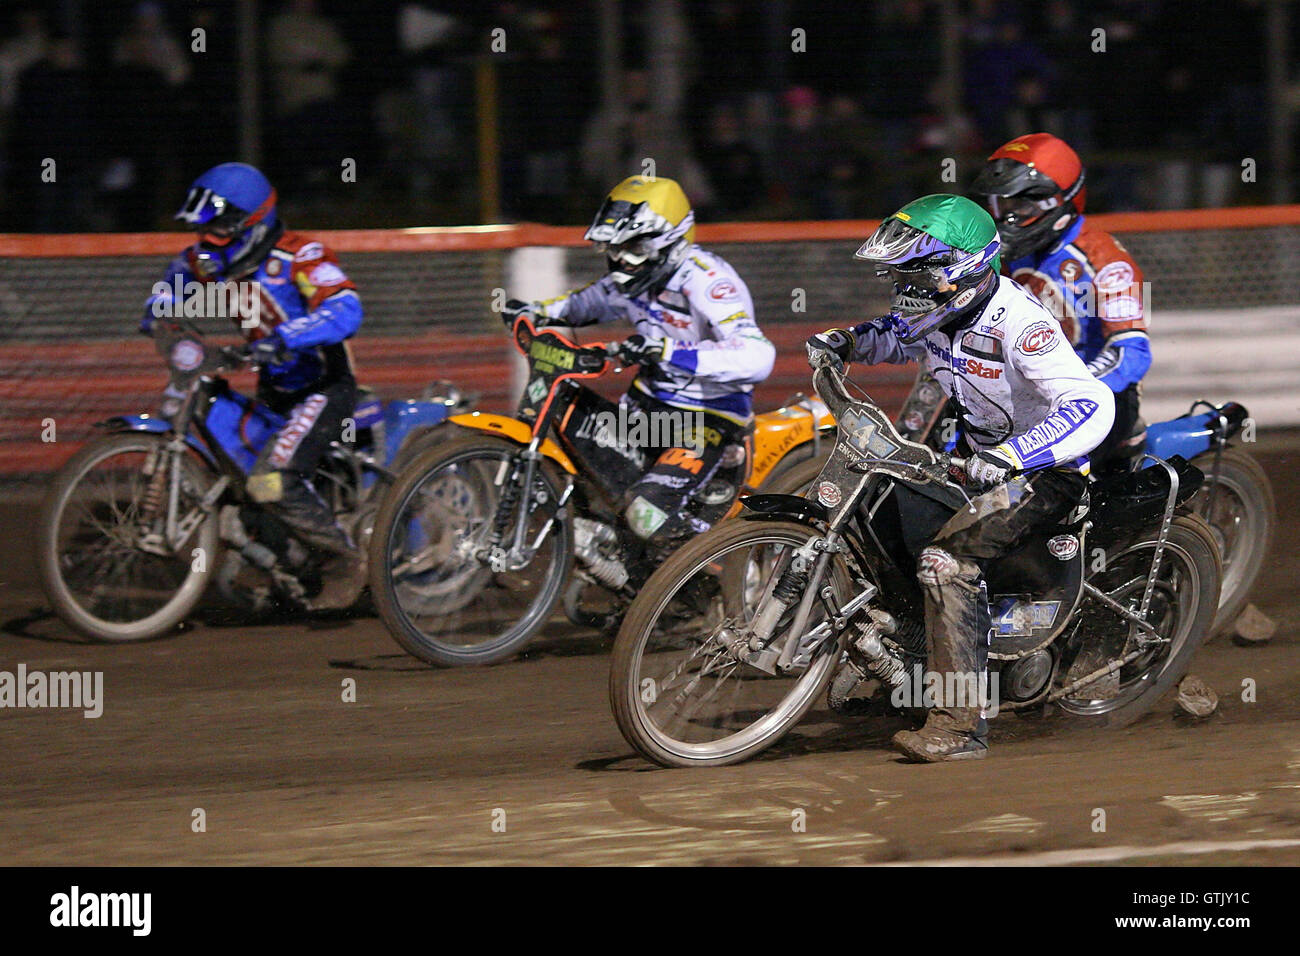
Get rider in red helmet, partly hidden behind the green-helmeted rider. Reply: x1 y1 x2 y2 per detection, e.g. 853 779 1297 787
972 133 1151 468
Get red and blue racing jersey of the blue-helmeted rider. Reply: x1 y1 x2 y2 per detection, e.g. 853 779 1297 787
142 233 361 393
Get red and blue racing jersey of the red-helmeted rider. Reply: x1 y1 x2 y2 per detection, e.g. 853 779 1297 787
1006 216 1151 392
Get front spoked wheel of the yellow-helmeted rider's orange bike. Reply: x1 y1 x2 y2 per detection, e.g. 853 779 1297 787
371 437 572 666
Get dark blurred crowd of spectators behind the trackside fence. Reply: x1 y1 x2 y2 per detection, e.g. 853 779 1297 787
0 0 1279 232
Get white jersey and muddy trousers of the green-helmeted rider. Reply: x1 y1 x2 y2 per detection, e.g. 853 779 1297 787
852 276 1114 737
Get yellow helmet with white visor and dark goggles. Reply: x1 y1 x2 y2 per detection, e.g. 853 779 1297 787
584 176 696 295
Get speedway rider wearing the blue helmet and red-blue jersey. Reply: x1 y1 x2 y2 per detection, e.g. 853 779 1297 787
140 163 365 609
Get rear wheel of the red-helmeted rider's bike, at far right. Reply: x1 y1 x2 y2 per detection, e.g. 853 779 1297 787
1192 450 1277 631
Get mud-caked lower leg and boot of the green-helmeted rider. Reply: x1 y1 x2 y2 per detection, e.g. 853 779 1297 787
893 546 989 763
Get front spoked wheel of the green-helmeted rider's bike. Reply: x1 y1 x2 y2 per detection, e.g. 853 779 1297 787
610 520 852 766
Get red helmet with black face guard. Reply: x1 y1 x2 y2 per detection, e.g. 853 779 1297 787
971 133 1088 261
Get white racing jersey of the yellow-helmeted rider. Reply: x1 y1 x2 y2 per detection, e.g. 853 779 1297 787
537 246 776 424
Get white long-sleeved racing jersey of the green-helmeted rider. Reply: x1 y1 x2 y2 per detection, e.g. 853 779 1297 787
853 276 1115 473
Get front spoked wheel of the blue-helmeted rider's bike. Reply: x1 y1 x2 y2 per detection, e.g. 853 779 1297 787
36 433 221 641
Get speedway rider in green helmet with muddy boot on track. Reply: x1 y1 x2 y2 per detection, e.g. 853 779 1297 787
807 195 1114 761
